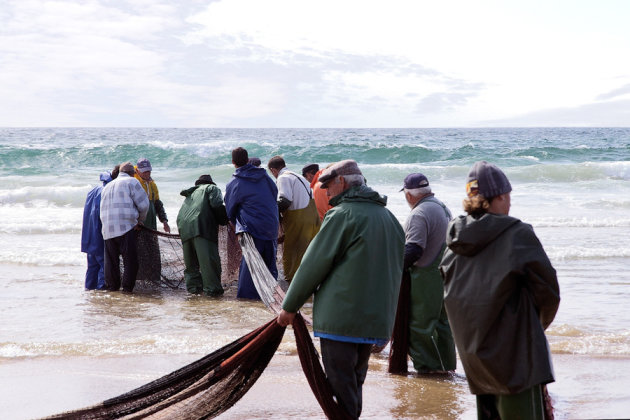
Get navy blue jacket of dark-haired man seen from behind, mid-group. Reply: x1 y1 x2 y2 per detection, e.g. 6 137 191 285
225 163 279 240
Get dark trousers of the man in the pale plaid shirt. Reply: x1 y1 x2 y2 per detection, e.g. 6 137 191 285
105 229 138 292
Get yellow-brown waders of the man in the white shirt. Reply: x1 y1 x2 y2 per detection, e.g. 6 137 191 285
282 198 321 282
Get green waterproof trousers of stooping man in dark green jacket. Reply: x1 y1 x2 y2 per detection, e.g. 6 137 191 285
182 236 223 296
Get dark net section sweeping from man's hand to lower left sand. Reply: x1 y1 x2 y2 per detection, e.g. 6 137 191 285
47 319 285 420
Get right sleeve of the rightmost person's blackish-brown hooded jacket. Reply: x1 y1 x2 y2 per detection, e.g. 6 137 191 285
517 225 560 329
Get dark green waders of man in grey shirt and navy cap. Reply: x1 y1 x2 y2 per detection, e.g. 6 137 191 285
409 247 457 372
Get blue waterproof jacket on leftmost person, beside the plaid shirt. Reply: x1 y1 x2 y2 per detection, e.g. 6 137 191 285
81 172 112 255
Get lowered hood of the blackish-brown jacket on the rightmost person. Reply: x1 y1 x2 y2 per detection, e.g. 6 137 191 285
446 213 520 257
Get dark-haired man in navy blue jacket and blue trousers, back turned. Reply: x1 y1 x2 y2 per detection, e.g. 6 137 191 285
225 147 279 300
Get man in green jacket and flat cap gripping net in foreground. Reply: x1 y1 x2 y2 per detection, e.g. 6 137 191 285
278 160 405 418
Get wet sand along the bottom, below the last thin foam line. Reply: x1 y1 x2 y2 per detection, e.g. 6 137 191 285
0 344 630 420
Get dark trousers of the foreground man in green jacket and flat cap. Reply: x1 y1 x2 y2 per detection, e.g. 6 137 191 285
319 338 372 419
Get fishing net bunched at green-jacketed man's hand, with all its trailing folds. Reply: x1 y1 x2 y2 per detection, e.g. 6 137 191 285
46 234 350 420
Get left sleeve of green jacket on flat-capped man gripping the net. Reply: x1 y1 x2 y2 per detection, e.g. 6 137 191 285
282 208 352 312
